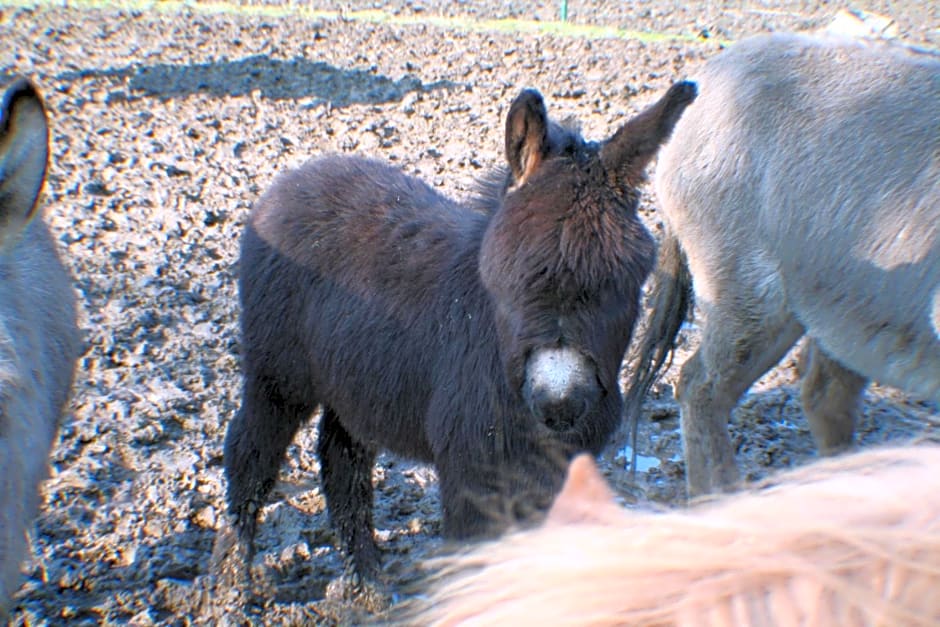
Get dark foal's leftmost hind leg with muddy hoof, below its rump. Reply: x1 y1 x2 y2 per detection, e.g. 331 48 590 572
213 377 314 576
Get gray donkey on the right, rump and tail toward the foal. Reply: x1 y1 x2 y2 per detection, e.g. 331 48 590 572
626 34 940 495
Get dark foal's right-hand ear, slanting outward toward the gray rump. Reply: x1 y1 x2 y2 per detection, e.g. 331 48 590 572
601 81 698 187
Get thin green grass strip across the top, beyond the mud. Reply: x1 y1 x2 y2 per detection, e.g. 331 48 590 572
0 0 712 43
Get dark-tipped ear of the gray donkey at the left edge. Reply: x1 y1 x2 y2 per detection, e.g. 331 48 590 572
0 78 49 247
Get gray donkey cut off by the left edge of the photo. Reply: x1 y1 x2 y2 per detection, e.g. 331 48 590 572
0 79 81 618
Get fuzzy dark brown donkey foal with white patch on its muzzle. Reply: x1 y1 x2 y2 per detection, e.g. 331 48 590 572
217 83 696 578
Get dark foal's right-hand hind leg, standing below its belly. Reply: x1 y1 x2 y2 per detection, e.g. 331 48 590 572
317 406 380 581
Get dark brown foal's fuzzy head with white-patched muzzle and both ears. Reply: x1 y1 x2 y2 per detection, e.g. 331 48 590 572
480 82 696 437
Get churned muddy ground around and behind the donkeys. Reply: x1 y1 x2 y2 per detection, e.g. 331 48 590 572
0 0 940 625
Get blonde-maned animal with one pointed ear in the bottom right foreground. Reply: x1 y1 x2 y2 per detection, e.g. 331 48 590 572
420 446 940 627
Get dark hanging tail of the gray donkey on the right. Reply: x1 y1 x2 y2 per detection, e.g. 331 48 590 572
623 226 693 476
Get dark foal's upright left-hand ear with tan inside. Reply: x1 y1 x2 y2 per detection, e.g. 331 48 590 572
506 89 548 185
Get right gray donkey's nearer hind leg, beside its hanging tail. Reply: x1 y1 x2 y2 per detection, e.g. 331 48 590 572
677 300 803 497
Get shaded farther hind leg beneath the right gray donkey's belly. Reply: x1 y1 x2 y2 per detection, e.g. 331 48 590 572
800 340 868 455
